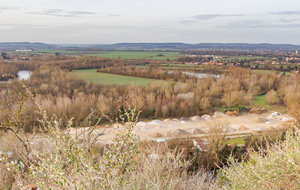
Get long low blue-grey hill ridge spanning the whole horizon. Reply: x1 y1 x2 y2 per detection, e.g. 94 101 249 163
0 42 300 50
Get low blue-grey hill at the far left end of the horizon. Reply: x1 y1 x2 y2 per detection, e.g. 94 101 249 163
0 42 57 50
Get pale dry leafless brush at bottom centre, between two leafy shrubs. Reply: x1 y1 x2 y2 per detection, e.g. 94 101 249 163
130 146 216 190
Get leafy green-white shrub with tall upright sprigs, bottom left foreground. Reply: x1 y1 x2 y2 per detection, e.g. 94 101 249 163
3 107 139 189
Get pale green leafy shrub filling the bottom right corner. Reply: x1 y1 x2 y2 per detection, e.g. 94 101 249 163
220 124 300 189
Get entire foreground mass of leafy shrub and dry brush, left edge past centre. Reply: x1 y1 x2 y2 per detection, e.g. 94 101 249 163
0 84 215 190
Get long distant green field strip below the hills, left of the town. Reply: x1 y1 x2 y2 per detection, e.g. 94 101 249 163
86 51 182 60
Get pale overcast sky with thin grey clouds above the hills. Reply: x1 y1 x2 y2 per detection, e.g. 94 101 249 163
0 0 300 45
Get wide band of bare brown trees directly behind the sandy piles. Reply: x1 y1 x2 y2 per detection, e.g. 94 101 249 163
1 65 300 129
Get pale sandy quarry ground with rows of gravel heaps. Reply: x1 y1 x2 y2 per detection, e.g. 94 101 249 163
71 112 292 144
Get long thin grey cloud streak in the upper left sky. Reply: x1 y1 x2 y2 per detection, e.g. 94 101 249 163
28 9 95 17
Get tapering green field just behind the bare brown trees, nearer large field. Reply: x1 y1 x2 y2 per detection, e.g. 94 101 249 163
72 69 166 86
